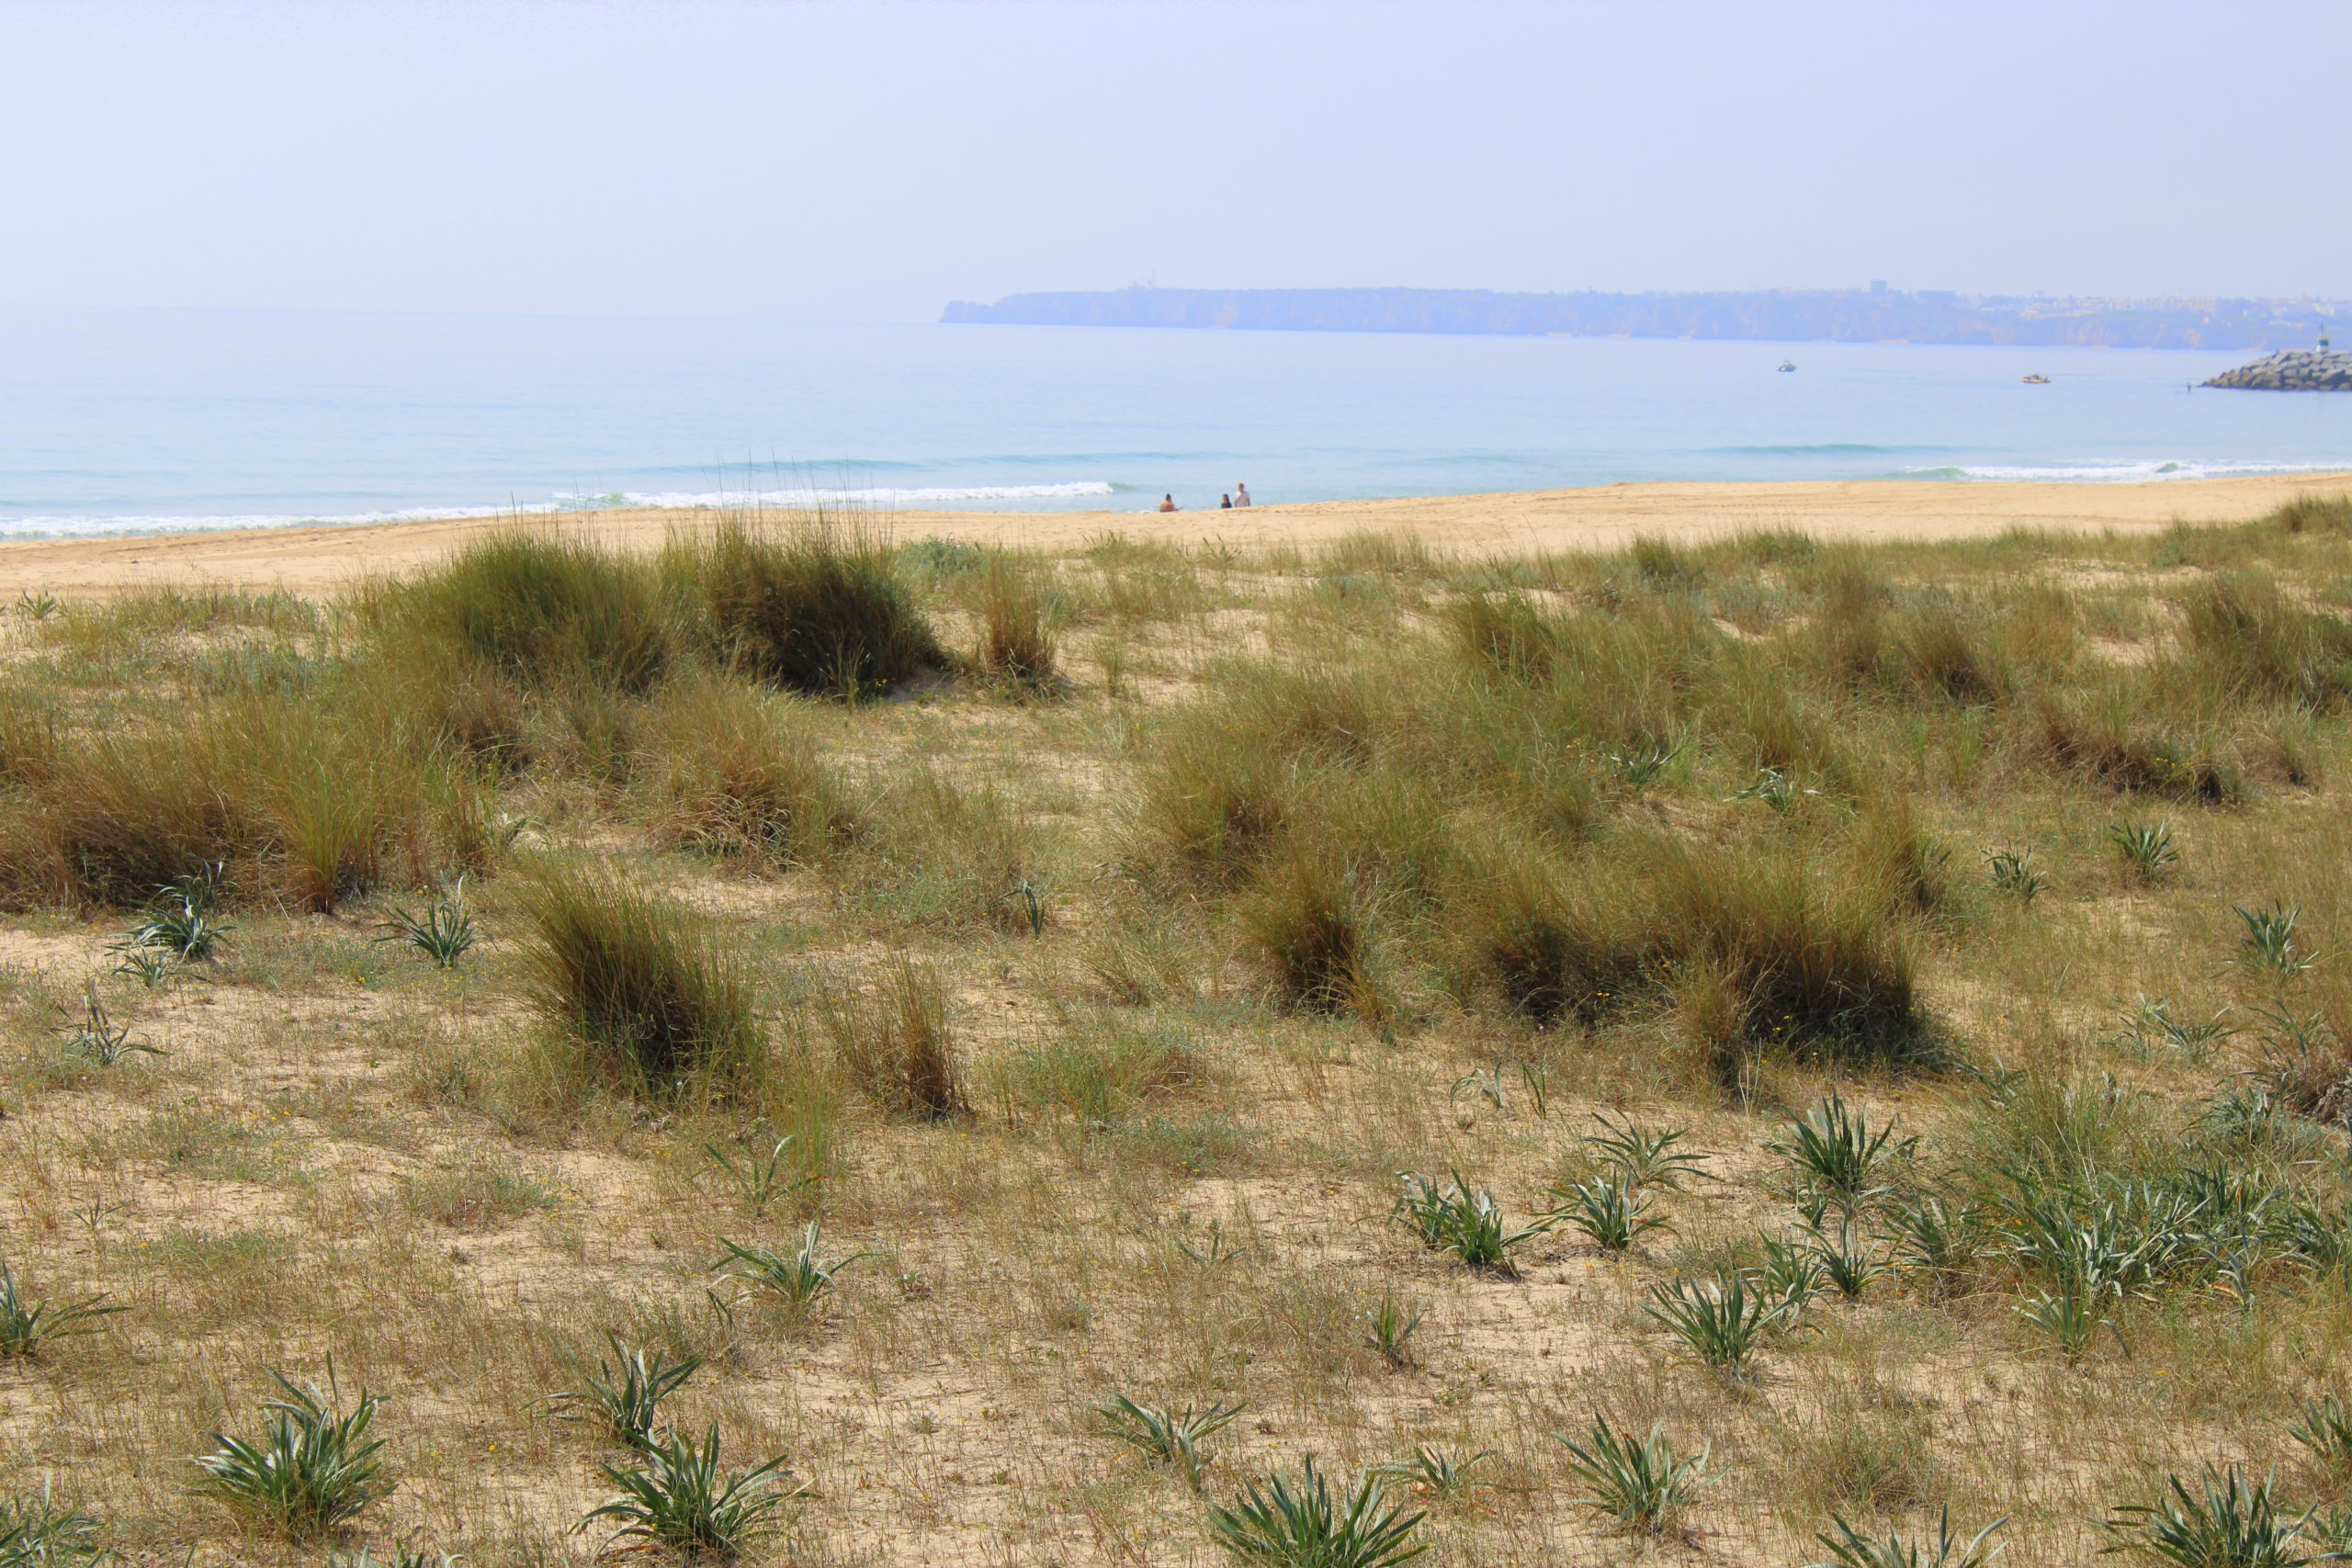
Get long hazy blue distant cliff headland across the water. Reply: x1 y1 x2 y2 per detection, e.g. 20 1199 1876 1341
941 289 2352 348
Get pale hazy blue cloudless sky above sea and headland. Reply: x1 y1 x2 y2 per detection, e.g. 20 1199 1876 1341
0 0 2352 320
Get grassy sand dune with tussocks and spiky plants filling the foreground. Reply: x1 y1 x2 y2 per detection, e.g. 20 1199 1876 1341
0 501 2352 1568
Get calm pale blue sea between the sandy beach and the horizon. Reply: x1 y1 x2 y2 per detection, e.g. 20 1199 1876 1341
0 308 2352 536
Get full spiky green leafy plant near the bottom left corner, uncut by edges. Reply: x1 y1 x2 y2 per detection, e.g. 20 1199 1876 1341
195 1368 393 1540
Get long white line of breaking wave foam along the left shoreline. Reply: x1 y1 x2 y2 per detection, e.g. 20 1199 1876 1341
0 479 1113 538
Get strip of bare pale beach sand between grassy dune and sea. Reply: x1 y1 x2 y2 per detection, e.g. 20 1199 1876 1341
0 472 2352 597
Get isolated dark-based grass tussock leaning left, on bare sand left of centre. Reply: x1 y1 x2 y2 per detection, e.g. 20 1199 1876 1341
522 867 764 1096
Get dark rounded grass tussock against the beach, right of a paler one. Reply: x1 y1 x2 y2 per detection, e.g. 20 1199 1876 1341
663 513 944 698
